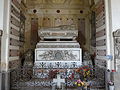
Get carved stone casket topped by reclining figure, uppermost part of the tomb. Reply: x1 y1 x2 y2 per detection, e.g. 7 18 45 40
38 25 78 39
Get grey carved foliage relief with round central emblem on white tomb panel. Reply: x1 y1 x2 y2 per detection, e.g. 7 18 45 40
39 50 77 60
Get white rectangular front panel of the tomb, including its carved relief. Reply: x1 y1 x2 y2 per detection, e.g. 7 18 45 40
36 50 80 61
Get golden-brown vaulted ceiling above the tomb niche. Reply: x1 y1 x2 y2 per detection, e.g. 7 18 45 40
27 0 89 9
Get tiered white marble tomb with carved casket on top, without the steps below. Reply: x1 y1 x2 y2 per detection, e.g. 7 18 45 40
35 25 82 68
